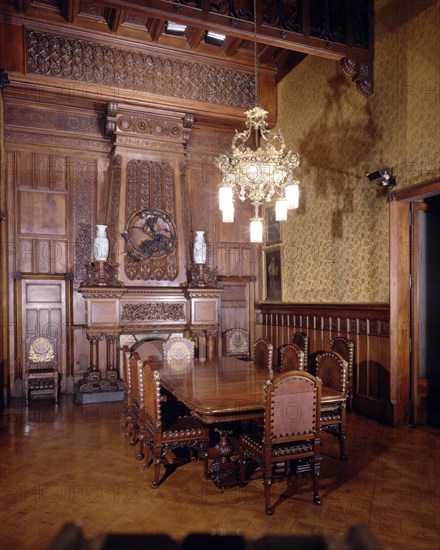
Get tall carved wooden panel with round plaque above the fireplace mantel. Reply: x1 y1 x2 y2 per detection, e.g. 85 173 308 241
124 160 179 281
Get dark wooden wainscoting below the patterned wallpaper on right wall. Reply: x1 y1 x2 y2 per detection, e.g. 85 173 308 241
255 304 394 423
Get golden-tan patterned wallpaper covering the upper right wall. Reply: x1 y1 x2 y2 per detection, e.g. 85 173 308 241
278 1 440 303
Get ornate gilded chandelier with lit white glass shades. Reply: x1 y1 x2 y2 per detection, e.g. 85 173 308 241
215 107 300 242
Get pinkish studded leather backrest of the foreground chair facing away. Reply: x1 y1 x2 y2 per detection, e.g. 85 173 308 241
265 371 321 443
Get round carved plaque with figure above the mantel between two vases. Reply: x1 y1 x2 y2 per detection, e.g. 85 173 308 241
123 208 177 260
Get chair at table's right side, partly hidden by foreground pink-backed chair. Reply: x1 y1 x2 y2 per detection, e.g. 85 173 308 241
316 351 348 460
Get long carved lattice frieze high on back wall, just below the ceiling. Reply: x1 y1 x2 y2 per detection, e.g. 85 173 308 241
27 31 255 109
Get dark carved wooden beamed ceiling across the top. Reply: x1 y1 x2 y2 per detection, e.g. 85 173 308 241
1 0 373 95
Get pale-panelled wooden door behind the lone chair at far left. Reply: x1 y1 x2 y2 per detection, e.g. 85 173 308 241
16 278 70 398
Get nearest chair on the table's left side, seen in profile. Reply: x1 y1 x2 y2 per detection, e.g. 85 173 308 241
138 361 209 489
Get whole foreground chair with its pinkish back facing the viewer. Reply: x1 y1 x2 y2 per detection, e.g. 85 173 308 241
240 371 321 515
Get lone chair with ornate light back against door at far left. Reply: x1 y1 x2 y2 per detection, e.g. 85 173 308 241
24 336 60 405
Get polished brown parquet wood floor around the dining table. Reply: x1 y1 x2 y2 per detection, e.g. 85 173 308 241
0 396 440 550
